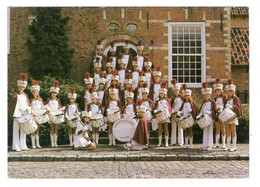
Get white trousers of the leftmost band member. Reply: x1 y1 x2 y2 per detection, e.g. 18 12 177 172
12 118 27 150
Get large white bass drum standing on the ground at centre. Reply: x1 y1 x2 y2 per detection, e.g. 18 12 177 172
113 118 137 142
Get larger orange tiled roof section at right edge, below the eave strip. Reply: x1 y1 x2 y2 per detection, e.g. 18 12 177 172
231 27 249 64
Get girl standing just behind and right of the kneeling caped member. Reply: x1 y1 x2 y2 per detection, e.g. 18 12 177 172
142 83 154 139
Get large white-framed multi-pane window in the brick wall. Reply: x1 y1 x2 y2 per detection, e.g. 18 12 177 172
168 23 206 87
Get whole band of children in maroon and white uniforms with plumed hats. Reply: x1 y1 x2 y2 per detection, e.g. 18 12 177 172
9 42 242 151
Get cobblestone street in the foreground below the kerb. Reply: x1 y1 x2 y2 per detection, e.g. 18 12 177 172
8 161 249 178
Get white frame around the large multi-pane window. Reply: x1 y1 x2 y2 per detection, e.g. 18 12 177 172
168 22 206 88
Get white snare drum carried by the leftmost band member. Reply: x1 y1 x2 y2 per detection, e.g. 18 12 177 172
18 115 38 134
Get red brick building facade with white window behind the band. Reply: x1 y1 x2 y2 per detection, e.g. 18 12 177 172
8 7 249 102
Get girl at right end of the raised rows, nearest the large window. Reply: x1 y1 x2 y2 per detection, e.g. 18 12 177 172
149 66 162 102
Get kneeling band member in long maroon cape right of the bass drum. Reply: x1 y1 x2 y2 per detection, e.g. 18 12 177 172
124 100 149 150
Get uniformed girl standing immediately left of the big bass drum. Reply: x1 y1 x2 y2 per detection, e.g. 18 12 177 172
104 83 122 146
